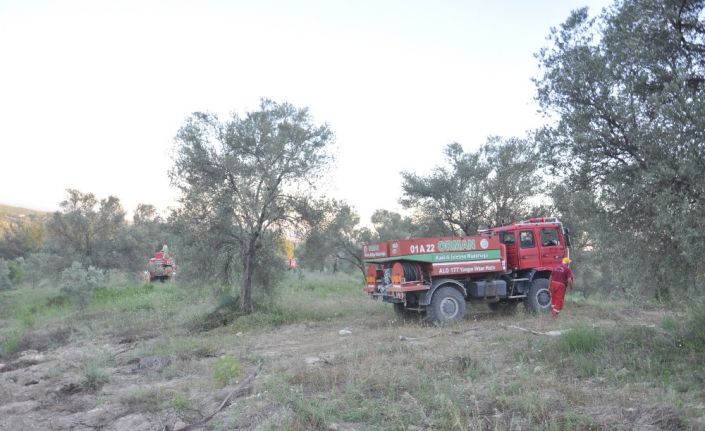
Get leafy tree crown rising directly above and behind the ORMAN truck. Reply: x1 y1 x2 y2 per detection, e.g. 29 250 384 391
400 137 541 235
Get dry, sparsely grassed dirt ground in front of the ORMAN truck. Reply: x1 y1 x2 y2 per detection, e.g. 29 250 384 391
0 296 705 431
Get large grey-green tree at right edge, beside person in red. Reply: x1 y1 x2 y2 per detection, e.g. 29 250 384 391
536 0 705 300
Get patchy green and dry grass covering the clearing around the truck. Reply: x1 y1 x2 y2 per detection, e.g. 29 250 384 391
0 274 705 430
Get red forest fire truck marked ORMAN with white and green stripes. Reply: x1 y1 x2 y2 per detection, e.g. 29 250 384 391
363 217 570 324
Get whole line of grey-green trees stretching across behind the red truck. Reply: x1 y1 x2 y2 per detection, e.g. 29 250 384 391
0 0 705 312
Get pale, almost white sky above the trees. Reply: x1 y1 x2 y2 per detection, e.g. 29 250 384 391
0 0 611 223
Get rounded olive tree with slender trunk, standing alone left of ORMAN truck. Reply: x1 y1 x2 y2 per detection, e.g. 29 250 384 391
171 99 333 313
